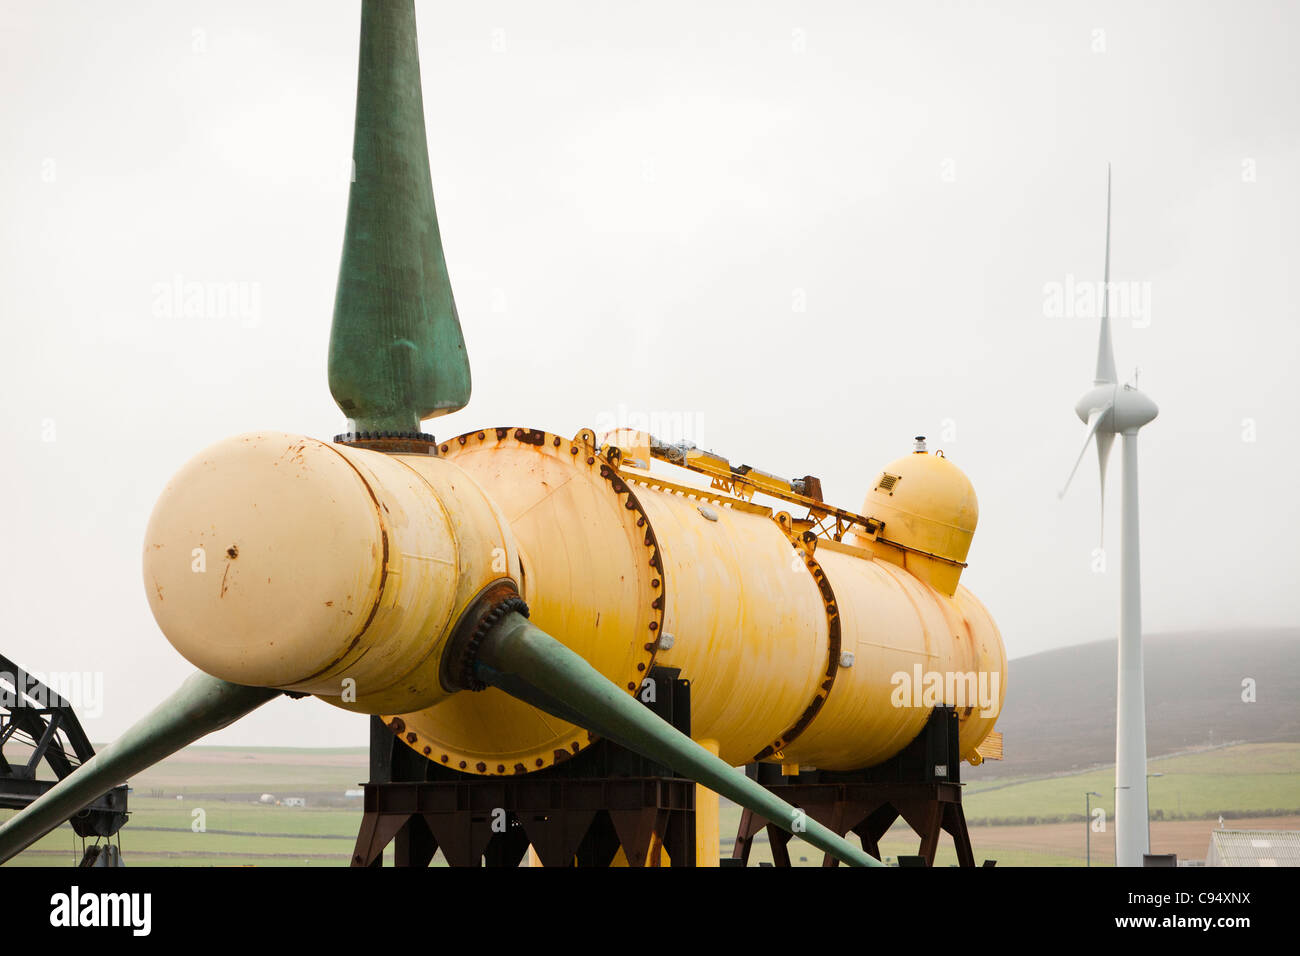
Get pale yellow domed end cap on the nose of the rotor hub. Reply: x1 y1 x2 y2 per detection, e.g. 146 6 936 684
144 432 385 689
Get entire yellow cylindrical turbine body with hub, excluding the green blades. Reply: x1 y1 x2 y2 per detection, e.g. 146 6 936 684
144 428 1006 774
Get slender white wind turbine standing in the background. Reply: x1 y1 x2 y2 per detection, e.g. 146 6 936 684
1061 165 1158 866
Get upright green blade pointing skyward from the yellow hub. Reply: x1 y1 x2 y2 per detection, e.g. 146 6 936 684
329 0 469 432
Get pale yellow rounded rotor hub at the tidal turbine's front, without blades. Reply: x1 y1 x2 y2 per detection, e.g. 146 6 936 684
144 432 519 713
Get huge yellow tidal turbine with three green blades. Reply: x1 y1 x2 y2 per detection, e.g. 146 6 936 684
0 0 1006 866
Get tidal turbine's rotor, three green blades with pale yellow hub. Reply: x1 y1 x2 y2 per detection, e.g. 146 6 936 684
0 0 881 866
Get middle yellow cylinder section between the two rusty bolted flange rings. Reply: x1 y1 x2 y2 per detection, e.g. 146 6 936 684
633 481 828 763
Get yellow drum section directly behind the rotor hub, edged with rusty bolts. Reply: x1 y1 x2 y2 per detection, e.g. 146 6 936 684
389 428 664 775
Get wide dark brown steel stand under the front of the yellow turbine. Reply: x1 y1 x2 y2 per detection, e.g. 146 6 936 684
352 667 696 866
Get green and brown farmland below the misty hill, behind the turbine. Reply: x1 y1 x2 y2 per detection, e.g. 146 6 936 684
0 744 1300 866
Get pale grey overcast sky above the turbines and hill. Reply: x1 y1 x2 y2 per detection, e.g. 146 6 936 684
0 0 1300 745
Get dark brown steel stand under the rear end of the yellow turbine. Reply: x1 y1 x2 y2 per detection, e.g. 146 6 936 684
732 708 975 866
